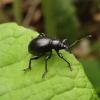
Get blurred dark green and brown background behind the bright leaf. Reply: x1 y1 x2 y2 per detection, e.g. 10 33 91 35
0 0 100 96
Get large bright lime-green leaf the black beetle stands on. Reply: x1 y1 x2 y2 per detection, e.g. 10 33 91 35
0 23 99 100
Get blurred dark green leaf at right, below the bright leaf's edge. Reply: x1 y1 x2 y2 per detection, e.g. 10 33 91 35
80 59 100 95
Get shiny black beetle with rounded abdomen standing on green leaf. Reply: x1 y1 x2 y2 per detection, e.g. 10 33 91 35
24 33 90 78
